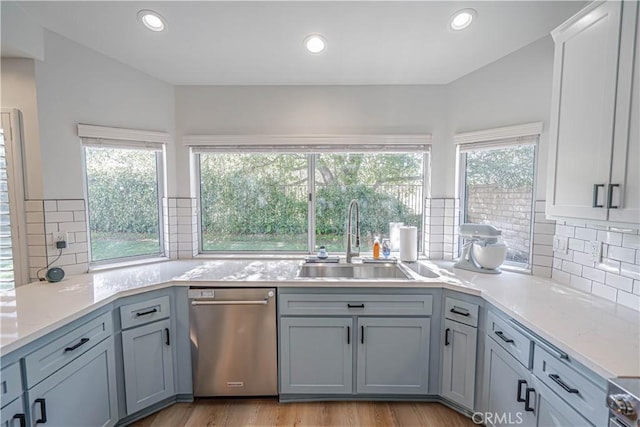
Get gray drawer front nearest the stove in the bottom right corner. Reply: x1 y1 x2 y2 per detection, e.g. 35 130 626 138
533 346 608 425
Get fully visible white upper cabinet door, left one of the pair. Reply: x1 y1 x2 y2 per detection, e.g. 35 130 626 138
547 1 622 220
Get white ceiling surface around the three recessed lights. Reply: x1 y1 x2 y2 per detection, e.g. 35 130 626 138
13 1 584 85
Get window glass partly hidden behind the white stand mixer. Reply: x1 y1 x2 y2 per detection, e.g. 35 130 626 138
460 131 537 268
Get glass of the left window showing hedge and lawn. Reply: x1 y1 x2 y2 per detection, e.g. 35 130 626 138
85 145 163 263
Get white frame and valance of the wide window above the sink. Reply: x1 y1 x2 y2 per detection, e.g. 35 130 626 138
190 135 431 256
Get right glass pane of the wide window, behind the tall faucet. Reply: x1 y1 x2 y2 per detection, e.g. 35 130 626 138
315 153 425 252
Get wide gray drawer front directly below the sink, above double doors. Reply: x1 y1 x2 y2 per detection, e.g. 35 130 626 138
280 294 433 316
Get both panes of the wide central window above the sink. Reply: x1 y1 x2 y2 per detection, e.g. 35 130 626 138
194 140 428 253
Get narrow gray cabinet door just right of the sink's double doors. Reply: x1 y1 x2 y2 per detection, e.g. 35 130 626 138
442 319 478 411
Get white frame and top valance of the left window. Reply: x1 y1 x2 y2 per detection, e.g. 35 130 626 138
78 124 169 269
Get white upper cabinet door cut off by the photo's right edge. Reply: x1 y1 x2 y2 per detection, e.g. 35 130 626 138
609 1 640 224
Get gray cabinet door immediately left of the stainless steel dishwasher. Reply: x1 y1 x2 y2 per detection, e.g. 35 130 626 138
122 319 174 415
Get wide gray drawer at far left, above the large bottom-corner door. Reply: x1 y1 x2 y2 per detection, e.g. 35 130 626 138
24 312 113 388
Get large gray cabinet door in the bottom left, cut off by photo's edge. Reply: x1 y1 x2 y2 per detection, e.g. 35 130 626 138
26 337 118 427
